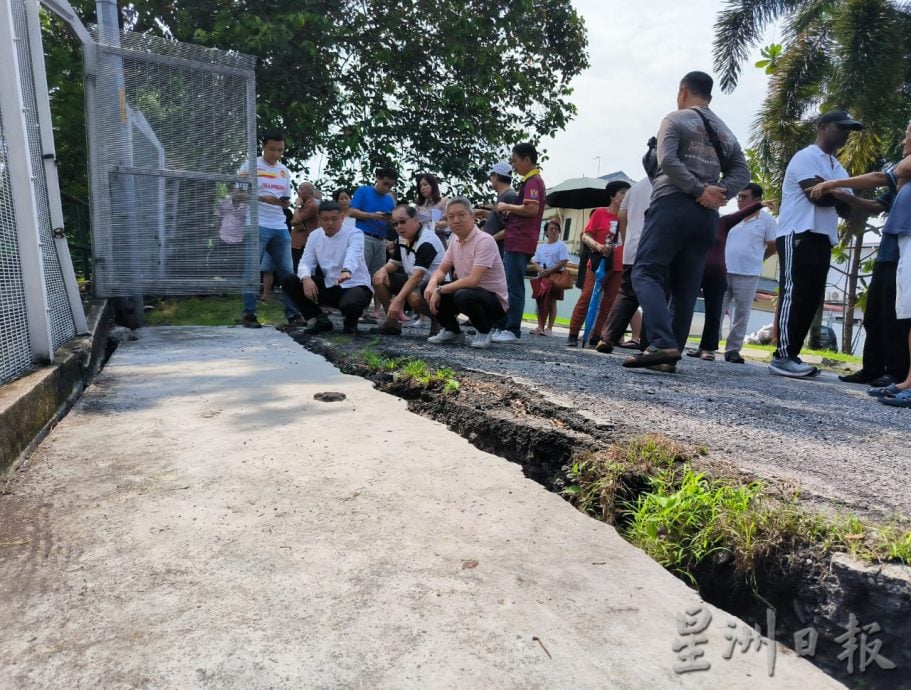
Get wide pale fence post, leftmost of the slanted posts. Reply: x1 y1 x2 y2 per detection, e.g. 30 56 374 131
0 0 54 362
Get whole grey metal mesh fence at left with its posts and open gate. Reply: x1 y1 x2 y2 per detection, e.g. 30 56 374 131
0 0 259 383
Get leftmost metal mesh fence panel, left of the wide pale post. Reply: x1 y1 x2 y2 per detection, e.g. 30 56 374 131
0 104 32 383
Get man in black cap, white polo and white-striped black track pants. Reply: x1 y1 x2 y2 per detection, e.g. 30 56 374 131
769 110 870 378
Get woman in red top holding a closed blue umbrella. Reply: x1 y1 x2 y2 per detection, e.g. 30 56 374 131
566 180 630 347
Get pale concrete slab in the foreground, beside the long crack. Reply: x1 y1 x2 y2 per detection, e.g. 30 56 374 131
0 328 841 689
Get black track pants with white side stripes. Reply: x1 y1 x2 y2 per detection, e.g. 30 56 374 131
775 230 832 358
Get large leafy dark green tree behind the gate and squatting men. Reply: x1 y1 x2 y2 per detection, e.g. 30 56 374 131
47 0 588 199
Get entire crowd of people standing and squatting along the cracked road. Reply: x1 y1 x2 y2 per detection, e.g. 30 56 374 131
233 72 911 406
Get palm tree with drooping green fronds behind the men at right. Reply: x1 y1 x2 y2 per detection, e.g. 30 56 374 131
714 0 911 352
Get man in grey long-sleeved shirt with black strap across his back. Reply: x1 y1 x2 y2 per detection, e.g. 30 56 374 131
623 72 750 372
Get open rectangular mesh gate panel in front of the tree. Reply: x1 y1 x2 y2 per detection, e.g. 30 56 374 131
90 27 259 296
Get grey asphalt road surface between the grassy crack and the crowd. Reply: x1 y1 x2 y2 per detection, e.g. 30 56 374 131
328 325 911 517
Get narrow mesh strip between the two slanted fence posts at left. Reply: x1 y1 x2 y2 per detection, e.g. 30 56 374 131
12 0 76 349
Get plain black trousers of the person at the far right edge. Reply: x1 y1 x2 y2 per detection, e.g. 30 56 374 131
863 261 911 381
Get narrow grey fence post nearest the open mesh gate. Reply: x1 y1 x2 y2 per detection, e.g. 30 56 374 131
25 0 89 333
